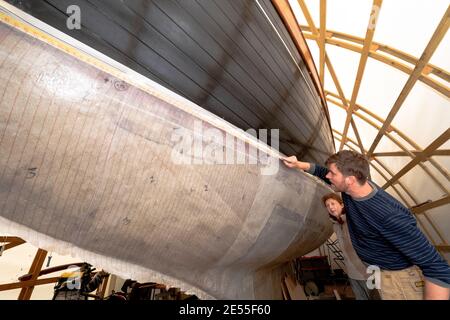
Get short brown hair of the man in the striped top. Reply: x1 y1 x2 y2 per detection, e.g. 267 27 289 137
325 150 370 185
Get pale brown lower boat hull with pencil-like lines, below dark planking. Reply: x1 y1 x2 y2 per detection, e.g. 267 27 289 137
0 20 331 299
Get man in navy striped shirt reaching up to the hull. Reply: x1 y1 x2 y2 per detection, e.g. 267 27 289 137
284 150 450 300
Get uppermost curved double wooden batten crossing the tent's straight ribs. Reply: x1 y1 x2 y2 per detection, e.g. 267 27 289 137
300 26 450 97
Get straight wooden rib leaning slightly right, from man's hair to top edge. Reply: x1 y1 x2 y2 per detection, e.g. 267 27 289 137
339 0 383 150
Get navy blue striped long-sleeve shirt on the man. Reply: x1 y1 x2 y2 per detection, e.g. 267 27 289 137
308 164 450 288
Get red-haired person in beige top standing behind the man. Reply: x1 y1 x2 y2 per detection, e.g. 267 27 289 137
322 193 380 300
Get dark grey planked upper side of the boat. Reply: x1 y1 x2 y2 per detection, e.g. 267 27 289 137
7 0 334 163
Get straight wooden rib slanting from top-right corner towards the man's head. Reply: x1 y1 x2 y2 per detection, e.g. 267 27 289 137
368 6 450 157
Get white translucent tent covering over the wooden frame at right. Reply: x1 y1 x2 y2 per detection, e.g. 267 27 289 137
289 0 450 260
